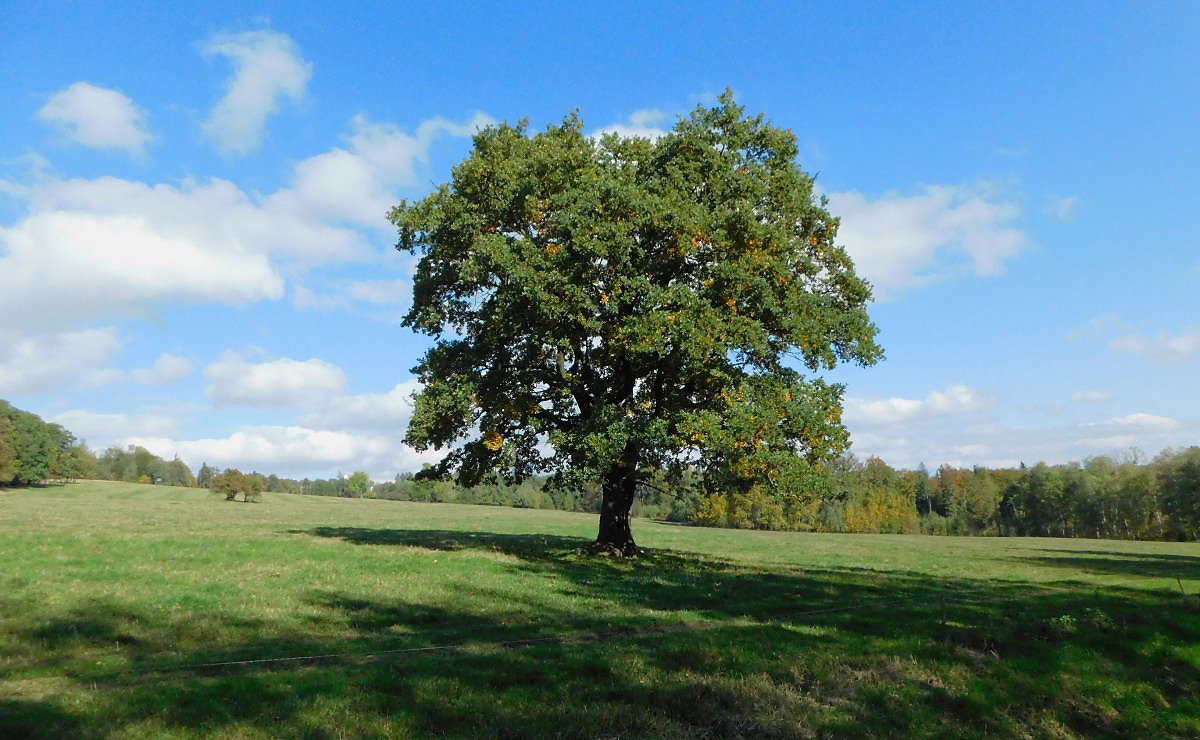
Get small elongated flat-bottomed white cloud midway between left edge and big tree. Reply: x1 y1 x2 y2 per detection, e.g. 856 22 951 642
204 353 348 408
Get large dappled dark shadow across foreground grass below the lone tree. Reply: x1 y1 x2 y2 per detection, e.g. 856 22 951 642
7 528 1200 738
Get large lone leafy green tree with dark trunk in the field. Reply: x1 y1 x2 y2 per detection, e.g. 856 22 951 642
391 92 882 553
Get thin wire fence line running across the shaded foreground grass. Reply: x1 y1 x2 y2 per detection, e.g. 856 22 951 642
0 568 1200 686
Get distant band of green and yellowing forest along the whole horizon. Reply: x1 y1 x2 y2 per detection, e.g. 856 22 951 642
0 401 1200 541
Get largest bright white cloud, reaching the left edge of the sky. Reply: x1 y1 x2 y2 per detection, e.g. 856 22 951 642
0 178 283 329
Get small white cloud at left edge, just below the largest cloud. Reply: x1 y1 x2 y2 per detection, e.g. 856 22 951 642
0 328 121 396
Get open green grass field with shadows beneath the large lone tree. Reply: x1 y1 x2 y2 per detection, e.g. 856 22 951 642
0 483 1200 738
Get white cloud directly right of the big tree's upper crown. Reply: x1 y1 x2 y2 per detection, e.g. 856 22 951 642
828 185 1026 297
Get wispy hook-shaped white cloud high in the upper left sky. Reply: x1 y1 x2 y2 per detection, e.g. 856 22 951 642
202 30 312 155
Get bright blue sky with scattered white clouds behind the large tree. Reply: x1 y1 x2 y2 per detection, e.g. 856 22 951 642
0 2 1200 479
